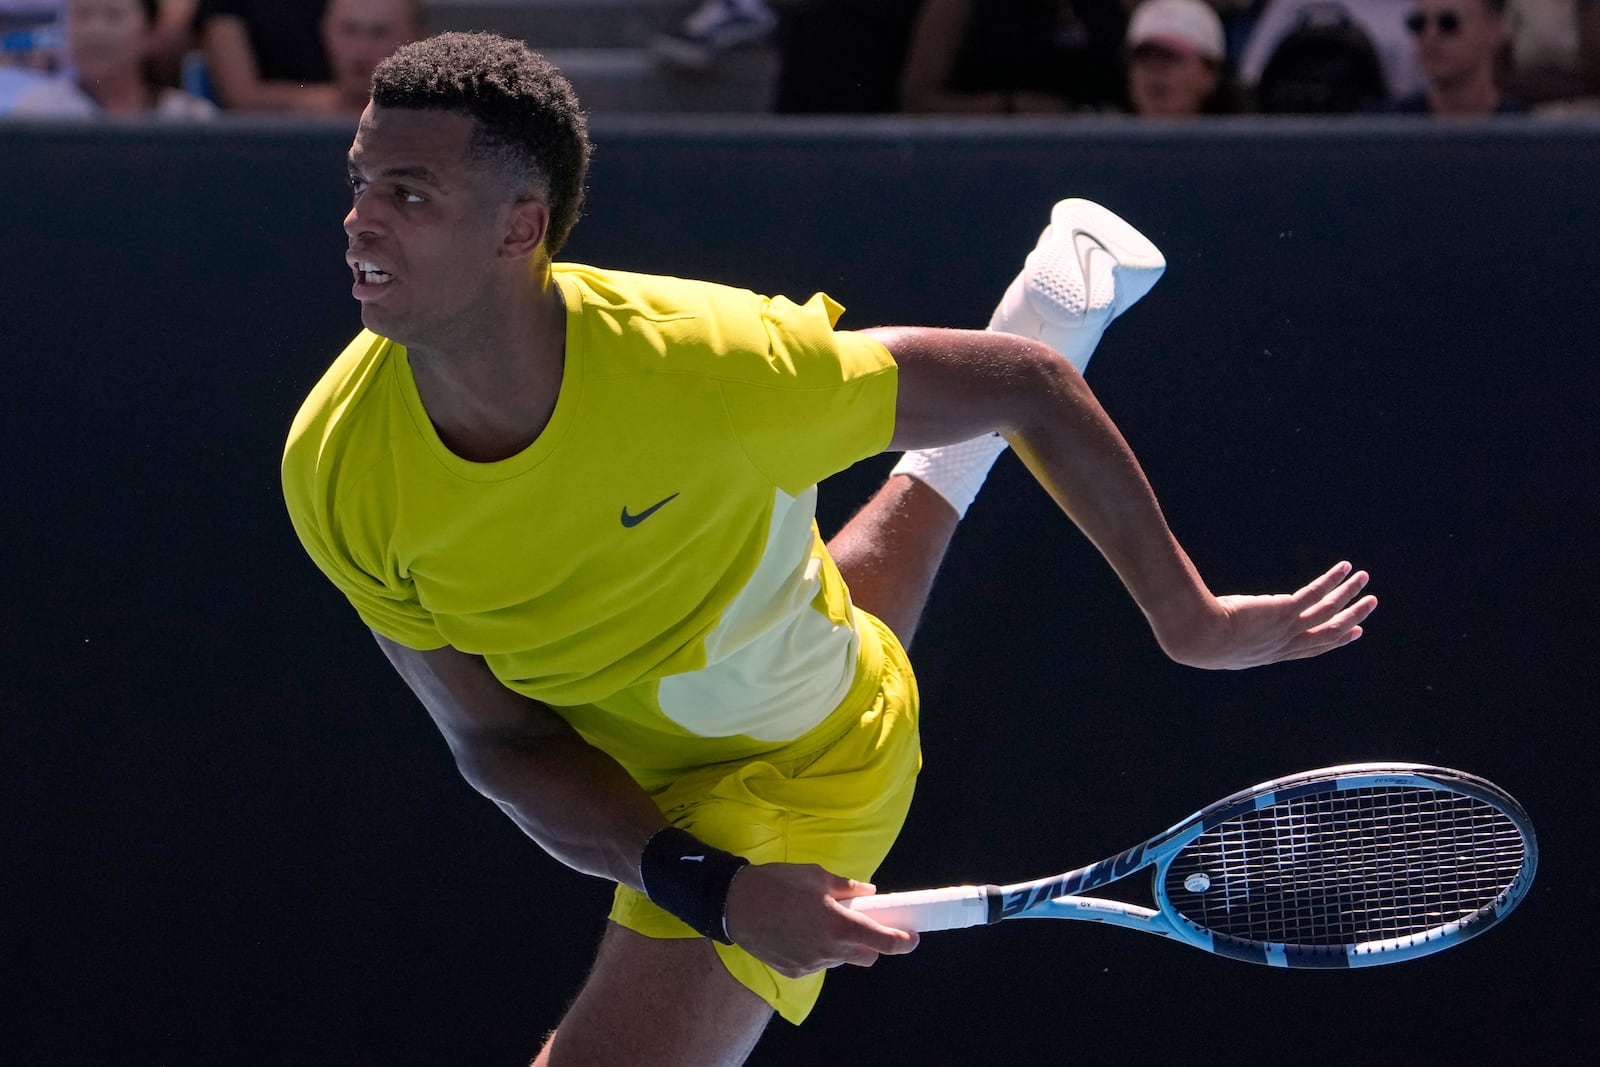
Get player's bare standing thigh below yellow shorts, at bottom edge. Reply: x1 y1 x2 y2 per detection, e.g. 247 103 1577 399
533 923 773 1067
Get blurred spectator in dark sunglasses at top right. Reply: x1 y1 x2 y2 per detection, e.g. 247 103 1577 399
1387 0 1526 115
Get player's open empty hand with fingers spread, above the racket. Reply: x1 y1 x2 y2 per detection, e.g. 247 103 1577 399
1157 563 1378 670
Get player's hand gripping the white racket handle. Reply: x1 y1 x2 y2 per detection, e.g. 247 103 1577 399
726 864 917 977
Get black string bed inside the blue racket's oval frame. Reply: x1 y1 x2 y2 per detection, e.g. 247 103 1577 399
1165 787 1525 947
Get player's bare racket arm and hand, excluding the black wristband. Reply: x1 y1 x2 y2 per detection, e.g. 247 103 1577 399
374 633 917 977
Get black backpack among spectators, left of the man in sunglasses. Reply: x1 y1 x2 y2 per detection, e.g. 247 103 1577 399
1254 3 1389 115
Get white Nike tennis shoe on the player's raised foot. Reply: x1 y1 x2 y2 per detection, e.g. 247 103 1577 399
989 198 1166 371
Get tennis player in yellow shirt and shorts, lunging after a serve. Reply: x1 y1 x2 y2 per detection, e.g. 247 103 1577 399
283 34 1374 1067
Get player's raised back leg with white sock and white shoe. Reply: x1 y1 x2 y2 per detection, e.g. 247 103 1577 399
827 200 1166 646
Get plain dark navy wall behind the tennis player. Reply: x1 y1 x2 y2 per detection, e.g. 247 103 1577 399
0 122 1600 1065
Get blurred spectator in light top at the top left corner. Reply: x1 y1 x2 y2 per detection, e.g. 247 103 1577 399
10 0 214 118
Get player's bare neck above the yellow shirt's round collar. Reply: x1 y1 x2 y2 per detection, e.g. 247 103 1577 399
406 264 566 462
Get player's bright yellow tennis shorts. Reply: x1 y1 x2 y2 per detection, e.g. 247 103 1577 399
611 609 922 1022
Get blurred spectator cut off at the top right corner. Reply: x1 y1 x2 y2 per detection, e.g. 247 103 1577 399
1506 0 1600 104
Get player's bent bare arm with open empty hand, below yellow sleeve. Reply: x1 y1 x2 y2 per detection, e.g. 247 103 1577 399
870 326 1378 669
